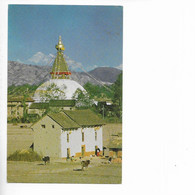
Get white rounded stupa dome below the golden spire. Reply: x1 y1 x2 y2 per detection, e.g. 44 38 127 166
33 79 86 102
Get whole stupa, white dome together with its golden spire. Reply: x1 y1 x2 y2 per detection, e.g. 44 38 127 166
33 36 86 102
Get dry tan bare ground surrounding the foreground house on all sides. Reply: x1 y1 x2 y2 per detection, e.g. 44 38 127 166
7 124 122 184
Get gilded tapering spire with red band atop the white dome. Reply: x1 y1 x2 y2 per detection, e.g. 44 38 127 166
50 36 71 79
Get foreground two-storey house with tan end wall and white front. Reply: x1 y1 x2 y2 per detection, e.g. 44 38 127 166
32 110 104 158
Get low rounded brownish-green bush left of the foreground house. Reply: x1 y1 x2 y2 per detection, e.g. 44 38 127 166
7 150 42 162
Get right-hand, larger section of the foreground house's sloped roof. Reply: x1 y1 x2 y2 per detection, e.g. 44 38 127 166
64 109 105 127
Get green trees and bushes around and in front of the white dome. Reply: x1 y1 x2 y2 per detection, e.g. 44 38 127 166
8 73 122 123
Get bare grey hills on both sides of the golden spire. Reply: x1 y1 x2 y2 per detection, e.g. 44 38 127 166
8 61 121 86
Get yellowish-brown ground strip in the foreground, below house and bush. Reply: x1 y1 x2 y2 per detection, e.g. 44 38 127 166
7 158 122 184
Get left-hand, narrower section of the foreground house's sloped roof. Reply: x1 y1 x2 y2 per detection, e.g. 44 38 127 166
48 112 80 129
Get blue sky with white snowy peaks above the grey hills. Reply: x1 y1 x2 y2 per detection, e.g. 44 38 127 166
8 5 123 70
